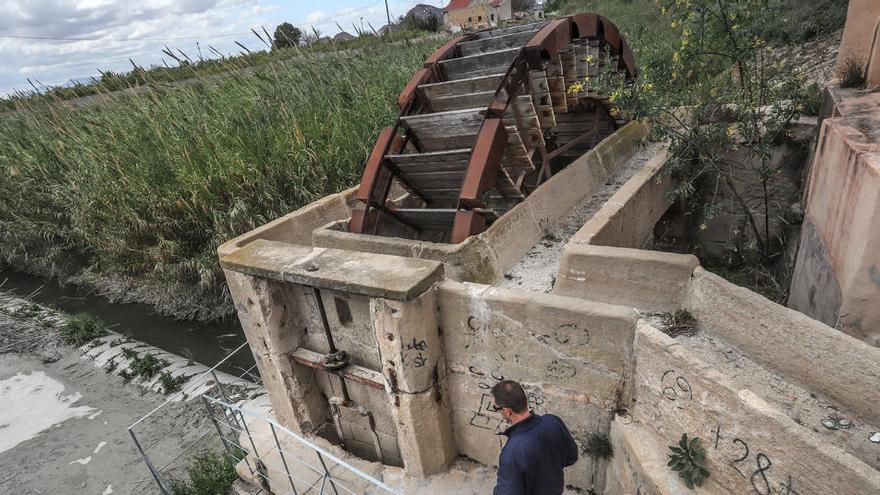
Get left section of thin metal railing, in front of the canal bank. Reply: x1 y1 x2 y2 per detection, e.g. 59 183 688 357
128 342 265 495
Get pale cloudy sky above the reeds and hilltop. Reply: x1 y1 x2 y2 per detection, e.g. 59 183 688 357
0 0 447 96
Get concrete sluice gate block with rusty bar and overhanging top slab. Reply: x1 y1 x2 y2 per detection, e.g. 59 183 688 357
221 243 454 476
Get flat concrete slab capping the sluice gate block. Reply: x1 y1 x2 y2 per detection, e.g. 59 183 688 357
220 240 443 301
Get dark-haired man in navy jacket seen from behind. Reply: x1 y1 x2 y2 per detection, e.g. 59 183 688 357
492 380 578 495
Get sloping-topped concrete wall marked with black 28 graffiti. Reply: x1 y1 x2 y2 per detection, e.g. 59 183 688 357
632 324 880 495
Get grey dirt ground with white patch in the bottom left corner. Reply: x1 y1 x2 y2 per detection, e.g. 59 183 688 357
0 349 205 495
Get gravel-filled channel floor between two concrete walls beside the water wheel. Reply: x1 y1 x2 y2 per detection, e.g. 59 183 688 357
495 143 661 292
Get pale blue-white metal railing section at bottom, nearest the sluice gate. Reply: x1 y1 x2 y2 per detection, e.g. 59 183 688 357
202 396 402 495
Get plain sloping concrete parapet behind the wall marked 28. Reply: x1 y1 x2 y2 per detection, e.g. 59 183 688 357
684 268 880 424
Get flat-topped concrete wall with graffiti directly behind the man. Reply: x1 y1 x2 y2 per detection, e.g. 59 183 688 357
439 282 636 493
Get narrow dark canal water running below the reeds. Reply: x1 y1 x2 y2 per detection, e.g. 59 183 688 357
0 266 254 375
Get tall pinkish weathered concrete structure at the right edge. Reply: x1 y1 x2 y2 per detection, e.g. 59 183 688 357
789 0 880 346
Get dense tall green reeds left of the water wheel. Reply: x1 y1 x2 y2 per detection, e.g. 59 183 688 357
0 38 444 317
